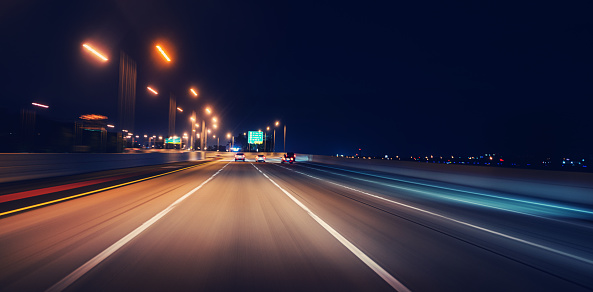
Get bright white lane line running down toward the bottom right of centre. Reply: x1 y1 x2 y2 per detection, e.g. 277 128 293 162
251 163 410 292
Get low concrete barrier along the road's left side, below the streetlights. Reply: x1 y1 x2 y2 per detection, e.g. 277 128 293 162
0 152 210 183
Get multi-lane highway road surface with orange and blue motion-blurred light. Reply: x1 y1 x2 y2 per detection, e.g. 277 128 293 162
0 155 593 291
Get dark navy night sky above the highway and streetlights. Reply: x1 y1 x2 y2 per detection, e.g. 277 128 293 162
0 0 593 155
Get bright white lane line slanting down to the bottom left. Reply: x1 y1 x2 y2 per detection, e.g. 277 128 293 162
46 163 228 292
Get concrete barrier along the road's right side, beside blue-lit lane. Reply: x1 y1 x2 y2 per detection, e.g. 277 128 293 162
297 154 593 206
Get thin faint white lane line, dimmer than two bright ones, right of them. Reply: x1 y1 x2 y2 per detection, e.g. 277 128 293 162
279 166 593 265
